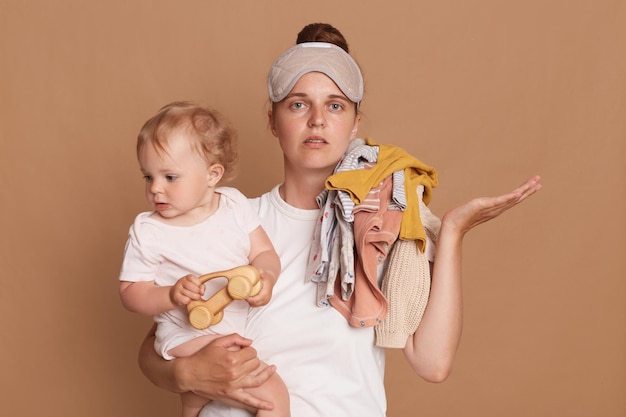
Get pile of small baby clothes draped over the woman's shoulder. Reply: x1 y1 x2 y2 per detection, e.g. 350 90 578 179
306 138 441 348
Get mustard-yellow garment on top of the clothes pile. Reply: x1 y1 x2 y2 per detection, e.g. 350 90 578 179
326 138 438 252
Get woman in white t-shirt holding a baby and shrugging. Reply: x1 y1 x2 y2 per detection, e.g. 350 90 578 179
140 24 541 417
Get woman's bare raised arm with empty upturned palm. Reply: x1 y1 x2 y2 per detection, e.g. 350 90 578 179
404 176 541 382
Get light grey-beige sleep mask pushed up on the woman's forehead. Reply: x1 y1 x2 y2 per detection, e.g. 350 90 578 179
267 42 363 103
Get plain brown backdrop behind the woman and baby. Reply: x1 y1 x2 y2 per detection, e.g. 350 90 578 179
0 0 626 417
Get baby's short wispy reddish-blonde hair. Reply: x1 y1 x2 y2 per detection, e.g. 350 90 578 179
137 101 238 180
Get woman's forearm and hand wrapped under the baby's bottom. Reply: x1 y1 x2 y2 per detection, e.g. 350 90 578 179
139 326 276 410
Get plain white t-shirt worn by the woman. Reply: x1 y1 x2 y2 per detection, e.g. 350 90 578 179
200 187 386 417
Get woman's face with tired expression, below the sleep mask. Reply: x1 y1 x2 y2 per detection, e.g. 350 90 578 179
270 72 360 175
